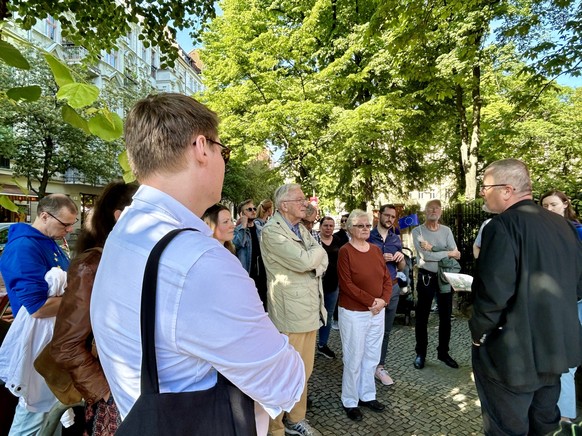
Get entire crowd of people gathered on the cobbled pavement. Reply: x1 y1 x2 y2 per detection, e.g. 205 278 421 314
0 94 582 436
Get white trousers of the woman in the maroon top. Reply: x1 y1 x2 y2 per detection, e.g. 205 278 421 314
338 307 385 407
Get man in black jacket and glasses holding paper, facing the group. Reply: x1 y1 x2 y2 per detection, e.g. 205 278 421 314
469 159 582 435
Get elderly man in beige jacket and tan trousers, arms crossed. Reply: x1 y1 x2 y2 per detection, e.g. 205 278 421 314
261 184 328 436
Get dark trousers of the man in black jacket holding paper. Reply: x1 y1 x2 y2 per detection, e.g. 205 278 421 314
472 347 560 436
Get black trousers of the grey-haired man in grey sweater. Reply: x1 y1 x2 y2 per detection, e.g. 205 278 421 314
414 269 453 357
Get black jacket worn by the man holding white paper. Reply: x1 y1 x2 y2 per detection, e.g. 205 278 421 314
469 200 582 386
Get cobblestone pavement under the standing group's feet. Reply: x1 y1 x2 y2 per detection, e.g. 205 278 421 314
307 314 483 436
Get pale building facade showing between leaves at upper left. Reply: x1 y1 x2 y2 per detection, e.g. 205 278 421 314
0 16 203 226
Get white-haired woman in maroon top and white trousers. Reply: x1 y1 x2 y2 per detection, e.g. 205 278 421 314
338 210 392 421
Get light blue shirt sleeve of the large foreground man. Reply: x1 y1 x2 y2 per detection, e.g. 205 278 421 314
176 249 305 418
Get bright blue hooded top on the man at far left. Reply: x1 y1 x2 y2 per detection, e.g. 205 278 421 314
0 223 69 316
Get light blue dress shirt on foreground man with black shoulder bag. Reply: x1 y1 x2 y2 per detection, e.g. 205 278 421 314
91 185 305 417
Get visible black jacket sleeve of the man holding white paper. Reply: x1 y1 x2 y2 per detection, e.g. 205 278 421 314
469 220 517 342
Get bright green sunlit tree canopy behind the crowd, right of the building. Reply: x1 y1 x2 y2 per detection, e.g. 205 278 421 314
202 0 580 208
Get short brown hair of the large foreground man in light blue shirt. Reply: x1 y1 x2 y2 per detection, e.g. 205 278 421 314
125 93 218 180
